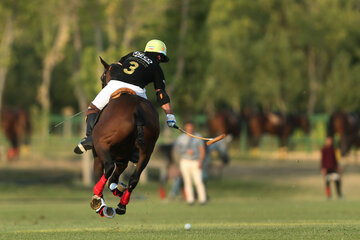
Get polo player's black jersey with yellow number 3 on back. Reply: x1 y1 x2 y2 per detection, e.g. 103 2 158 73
110 51 165 90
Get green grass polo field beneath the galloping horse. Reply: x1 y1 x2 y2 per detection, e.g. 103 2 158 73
0 157 360 240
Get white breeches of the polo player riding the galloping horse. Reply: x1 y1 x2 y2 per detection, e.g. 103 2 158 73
92 80 147 110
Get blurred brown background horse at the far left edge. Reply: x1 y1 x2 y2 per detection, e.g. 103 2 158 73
1 108 31 160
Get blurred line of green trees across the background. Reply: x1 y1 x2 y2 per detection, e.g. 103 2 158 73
0 0 360 135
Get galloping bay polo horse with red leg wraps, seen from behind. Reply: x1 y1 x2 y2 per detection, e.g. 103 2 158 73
90 58 160 218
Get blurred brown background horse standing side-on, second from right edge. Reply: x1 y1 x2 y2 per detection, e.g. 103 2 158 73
247 112 310 148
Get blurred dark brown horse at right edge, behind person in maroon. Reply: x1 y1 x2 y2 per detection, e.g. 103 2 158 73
327 112 360 156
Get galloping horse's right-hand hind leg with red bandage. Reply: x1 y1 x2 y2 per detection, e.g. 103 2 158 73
116 150 151 214
